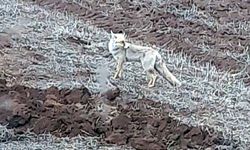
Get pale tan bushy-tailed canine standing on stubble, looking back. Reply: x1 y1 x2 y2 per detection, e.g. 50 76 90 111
108 31 181 88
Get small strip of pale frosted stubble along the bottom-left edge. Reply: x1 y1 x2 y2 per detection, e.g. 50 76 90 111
0 126 132 150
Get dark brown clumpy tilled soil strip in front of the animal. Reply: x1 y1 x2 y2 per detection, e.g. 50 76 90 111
0 80 236 149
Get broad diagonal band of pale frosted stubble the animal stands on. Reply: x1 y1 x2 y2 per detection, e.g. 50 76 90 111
0 0 250 146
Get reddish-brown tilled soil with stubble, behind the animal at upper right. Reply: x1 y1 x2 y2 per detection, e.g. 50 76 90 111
25 0 250 84
